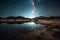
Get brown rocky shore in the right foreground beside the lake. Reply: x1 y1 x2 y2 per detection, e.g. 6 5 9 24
16 26 60 40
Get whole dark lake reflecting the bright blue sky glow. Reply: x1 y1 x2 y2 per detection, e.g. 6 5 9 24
0 22 45 40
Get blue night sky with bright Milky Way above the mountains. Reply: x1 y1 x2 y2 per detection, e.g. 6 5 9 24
0 0 60 18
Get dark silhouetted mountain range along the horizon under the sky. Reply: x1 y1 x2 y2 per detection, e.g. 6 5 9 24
0 16 60 19
